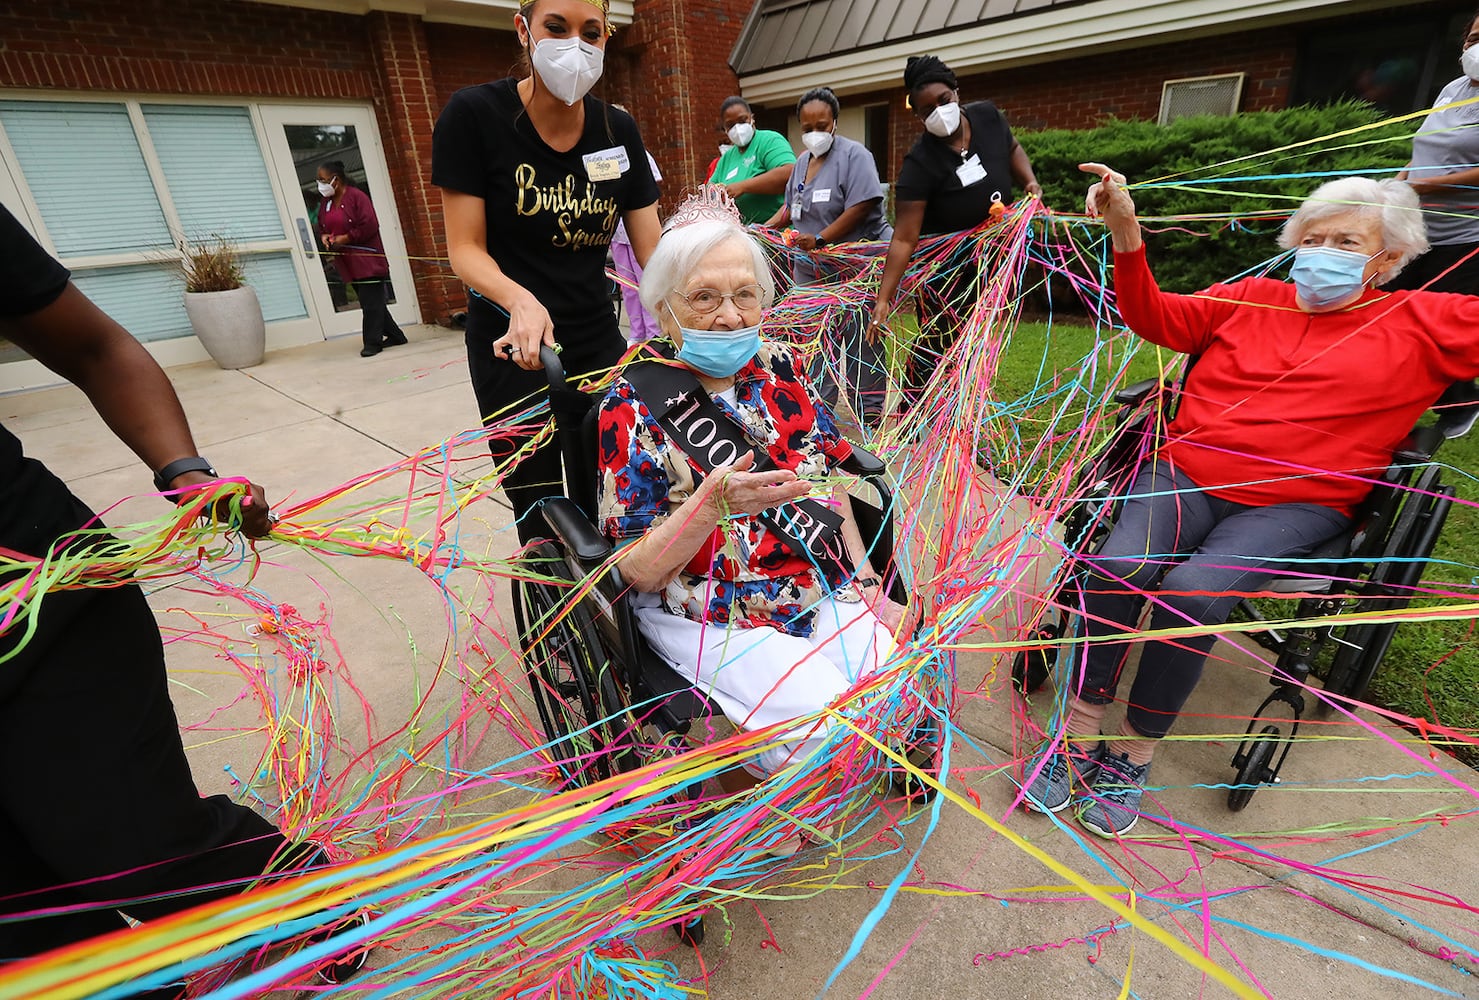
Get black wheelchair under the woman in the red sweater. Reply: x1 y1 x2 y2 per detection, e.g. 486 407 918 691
1012 371 1454 812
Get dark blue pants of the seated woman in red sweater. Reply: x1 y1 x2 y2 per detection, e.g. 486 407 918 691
1075 459 1350 738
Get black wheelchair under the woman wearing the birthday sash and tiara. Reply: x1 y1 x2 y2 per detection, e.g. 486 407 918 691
513 346 917 945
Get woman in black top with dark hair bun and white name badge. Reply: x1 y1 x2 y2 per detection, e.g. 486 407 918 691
868 56 1043 398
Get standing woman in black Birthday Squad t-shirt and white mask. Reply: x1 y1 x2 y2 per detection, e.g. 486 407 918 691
432 0 658 541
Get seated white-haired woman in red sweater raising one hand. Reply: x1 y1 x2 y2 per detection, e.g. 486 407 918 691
1025 164 1479 837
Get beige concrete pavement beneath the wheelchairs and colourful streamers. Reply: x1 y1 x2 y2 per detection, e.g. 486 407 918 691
0 327 1479 1000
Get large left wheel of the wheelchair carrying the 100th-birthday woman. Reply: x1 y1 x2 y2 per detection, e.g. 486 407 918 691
513 541 611 788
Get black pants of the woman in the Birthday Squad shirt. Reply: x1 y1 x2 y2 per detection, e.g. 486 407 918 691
466 311 627 543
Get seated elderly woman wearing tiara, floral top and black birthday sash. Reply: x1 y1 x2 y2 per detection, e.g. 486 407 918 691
598 192 904 780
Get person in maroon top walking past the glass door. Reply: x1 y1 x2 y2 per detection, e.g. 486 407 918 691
318 160 405 358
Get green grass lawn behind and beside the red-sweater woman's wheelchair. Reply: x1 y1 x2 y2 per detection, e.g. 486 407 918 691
911 316 1479 766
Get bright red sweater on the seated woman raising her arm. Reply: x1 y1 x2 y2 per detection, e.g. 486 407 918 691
1114 249 1479 513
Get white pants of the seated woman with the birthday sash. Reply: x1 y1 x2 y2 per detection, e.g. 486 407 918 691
636 595 893 774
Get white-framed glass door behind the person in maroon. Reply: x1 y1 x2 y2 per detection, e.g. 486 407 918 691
259 105 422 337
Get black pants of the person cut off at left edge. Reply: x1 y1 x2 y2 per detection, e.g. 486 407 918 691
0 586 303 962
